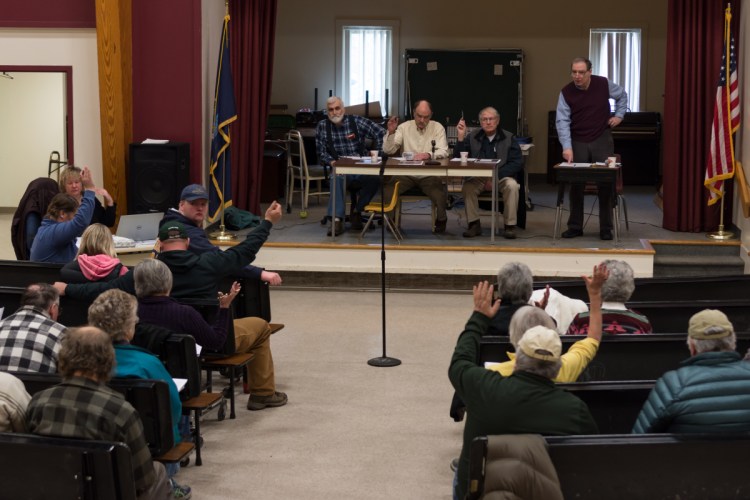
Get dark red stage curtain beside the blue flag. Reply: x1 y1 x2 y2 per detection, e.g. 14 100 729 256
229 0 277 214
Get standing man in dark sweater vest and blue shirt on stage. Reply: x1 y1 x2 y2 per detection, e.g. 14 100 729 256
556 57 628 240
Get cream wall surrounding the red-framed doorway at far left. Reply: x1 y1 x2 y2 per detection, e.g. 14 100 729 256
0 29 102 207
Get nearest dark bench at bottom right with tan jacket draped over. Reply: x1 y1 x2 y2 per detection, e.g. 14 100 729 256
468 434 750 500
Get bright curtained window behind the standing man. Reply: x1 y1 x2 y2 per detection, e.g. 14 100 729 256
589 29 641 111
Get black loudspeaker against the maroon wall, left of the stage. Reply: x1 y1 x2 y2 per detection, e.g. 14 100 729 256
128 142 190 214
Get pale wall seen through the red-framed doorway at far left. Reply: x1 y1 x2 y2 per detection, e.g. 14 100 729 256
0 71 66 206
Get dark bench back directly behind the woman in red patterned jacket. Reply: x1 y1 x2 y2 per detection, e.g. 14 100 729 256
479 332 750 382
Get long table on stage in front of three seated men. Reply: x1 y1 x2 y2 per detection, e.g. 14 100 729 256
331 157 497 243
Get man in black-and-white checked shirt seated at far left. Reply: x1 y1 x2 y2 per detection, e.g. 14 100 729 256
0 283 65 373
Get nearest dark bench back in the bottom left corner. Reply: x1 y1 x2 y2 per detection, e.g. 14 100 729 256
0 433 136 500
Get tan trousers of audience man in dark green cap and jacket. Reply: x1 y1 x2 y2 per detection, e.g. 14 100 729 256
234 318 276 396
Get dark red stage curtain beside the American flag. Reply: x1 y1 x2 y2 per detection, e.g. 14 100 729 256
663 0 740 232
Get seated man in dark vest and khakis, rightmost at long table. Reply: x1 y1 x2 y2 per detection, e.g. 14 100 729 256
453 107 526 240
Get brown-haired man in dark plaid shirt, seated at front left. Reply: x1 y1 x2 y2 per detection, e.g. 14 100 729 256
26 326 171 499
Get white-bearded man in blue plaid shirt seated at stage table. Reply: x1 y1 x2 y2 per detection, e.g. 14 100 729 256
315 96 385 236
